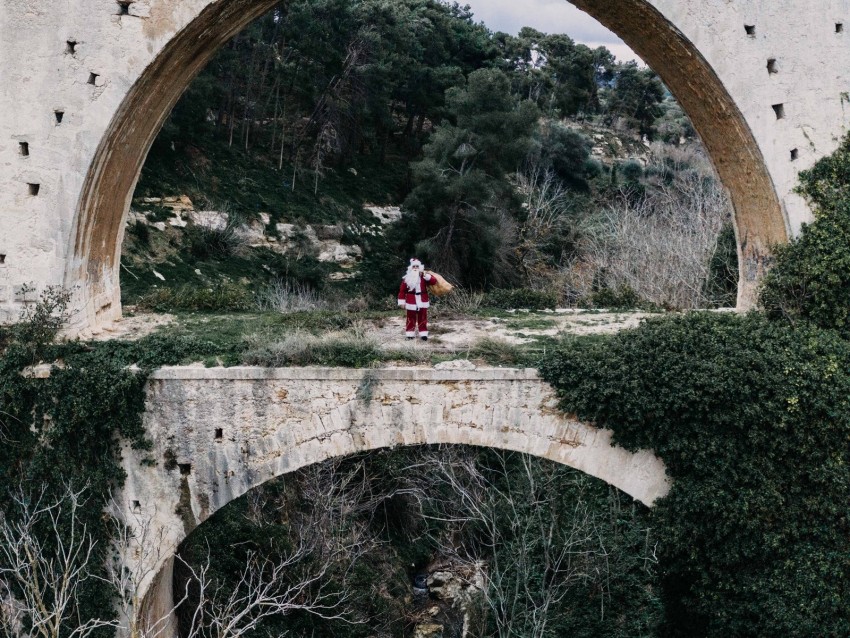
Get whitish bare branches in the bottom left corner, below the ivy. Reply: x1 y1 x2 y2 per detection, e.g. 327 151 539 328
0 484 116 638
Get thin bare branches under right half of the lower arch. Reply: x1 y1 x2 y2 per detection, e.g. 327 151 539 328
398 448 655 638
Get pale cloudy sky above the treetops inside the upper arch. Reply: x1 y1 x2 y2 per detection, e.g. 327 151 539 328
459 0 640 62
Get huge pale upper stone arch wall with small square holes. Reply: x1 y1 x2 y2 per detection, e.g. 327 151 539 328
0 0 850 332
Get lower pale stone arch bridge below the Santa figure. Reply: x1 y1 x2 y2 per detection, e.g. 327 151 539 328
117 367 670 633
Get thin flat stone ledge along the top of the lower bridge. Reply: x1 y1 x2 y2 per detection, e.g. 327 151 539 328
150 366 540 382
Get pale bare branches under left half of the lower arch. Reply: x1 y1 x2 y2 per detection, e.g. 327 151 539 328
168 460 381 638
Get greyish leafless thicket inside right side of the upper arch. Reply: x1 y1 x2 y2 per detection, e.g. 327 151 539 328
570 147 732 309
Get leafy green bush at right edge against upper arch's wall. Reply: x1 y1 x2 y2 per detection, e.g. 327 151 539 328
761 138 850 337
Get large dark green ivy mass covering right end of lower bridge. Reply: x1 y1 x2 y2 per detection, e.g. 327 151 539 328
542 313 850 638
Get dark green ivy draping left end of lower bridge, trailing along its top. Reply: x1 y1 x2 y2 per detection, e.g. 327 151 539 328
0 289 222 636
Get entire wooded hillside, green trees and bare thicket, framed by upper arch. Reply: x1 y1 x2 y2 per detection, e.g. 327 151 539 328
127 0 737 309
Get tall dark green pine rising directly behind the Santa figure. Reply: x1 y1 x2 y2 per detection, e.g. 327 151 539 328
404 69 539 285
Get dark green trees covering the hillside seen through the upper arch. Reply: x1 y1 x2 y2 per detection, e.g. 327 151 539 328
132 0 676 298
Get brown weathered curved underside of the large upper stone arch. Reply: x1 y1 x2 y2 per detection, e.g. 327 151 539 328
65 0 789 327
